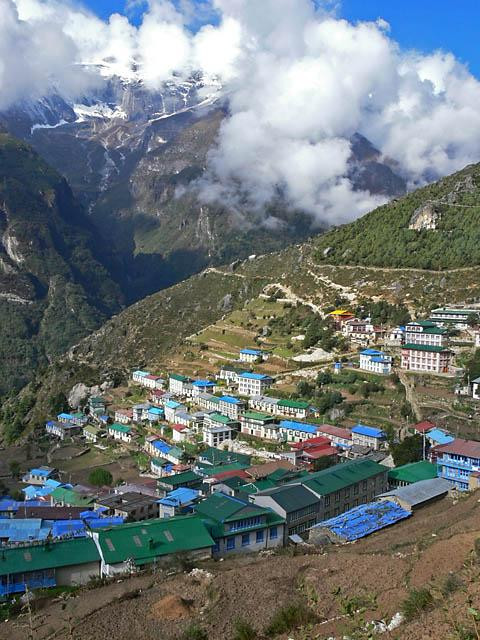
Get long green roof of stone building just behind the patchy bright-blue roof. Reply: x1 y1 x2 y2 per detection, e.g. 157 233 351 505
302 460 387 495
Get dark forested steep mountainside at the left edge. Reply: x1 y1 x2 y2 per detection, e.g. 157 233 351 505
0 133 122 394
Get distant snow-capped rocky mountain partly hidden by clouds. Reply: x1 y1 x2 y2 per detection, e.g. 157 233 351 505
0 71 405 301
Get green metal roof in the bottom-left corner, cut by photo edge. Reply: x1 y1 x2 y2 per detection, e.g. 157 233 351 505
0 538 100 576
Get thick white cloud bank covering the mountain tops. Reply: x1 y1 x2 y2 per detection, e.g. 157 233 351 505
0 0 480 223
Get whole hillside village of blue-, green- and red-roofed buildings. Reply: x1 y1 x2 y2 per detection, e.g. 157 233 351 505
0 307 480 599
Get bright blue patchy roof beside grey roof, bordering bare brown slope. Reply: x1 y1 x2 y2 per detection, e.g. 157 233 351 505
312 500 412 542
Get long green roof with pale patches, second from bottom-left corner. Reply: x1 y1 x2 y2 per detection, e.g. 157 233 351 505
97 516 214 565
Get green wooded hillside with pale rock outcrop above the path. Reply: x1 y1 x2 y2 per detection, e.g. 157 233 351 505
316 164 480 269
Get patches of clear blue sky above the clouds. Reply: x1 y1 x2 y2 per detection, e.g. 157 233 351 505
83 0 480 77
